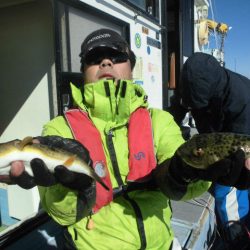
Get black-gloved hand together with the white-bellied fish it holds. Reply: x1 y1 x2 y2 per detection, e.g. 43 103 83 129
0 136 106 190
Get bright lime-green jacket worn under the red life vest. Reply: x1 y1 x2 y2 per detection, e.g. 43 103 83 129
39 80 209 250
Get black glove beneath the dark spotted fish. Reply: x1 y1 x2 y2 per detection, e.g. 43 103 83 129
169 150 250 189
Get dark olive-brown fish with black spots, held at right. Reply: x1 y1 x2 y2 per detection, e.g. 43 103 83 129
176 132 250 169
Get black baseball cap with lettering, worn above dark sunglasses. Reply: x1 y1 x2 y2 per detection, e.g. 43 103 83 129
79 29 136 69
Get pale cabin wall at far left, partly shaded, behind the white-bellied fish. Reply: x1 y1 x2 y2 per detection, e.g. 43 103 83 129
0 0 55 220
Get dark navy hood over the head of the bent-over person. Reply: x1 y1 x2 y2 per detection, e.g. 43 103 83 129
180 52 227 109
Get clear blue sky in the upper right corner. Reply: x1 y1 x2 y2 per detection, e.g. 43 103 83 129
208 0 250 78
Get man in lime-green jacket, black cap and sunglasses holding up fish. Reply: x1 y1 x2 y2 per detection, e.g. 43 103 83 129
8 29 249 250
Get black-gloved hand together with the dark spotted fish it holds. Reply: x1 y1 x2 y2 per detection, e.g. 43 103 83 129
172 133 250 189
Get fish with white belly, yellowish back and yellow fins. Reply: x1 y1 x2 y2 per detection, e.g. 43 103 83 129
0 137 109 190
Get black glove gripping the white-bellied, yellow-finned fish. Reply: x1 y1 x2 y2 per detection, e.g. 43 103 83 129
11 136 94 190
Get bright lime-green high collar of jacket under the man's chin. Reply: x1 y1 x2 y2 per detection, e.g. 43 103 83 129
71 80 148 127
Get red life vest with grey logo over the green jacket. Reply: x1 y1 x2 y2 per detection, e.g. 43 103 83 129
65 108 156 213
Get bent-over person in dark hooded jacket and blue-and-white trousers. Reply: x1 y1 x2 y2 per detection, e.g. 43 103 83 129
179 52 250 249
